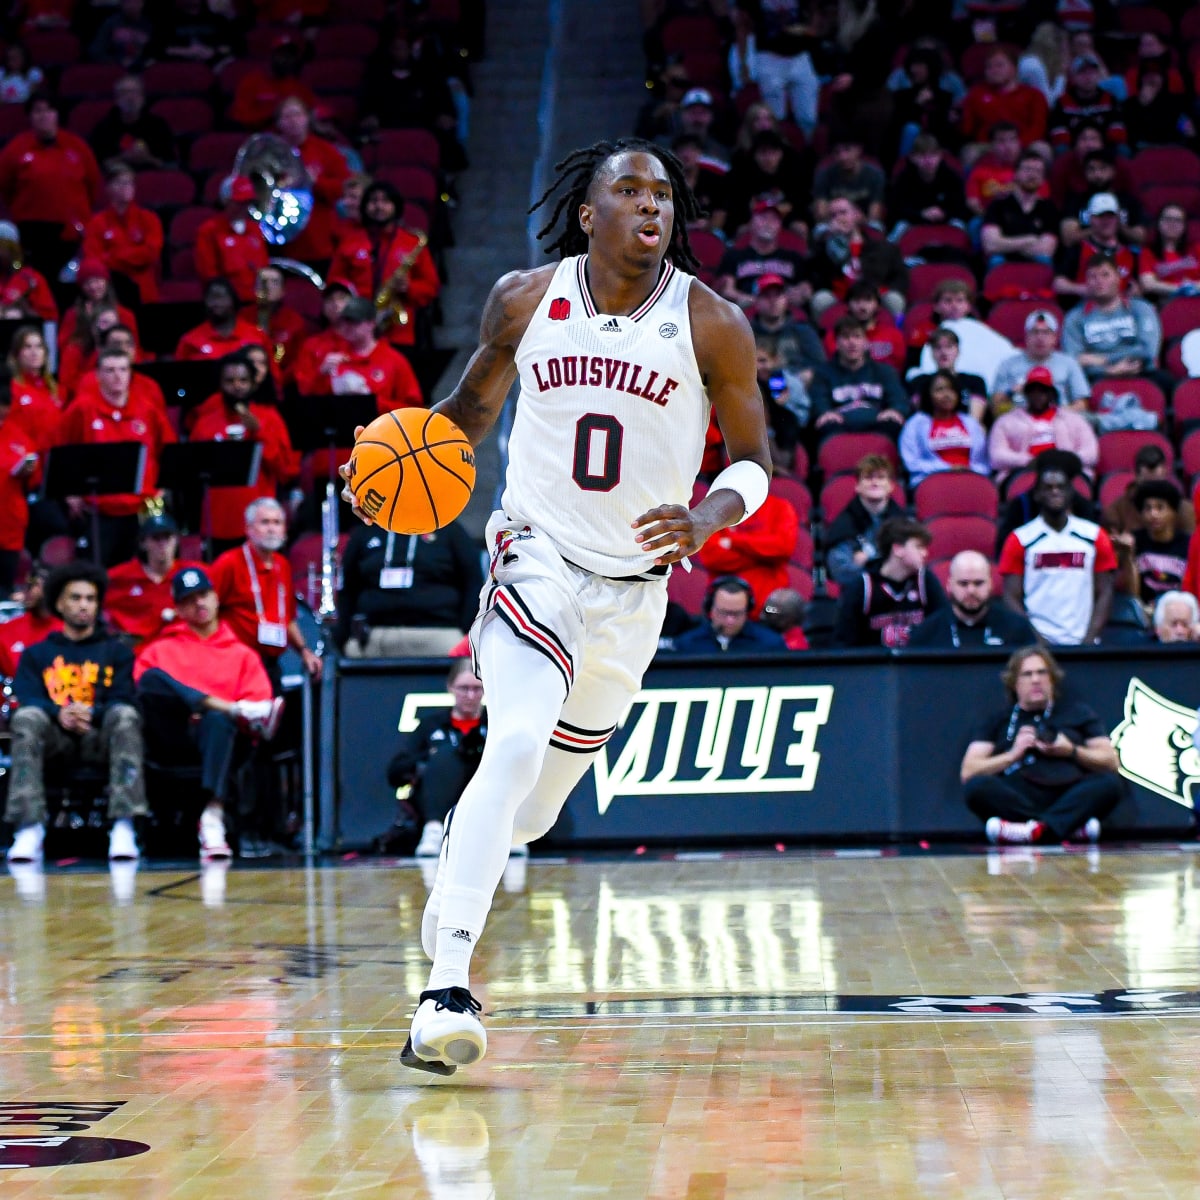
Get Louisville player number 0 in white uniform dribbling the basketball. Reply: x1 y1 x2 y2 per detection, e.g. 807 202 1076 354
343 139 770 1075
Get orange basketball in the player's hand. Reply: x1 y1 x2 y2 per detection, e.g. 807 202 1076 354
349 408 475 533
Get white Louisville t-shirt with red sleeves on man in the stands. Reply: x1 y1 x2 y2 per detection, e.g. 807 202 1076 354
1000 516 1117 646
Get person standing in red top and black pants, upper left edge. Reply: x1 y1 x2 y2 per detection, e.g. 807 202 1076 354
0 96 100 274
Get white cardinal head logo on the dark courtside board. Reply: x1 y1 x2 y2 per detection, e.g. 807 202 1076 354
1112 677 1200 809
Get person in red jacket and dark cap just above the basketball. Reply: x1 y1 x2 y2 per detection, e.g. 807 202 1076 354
295 296 425 414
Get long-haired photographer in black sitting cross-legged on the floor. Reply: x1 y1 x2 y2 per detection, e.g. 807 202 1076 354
960 646 1124 845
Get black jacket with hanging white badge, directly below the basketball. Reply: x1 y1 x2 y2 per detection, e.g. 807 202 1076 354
336 522 484 646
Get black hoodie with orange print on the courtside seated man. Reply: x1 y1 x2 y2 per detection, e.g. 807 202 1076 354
13 626 134 725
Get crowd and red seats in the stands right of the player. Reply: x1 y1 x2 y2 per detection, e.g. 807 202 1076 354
636 0 1200 650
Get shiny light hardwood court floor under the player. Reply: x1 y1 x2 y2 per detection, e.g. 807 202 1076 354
0 847 1200 1200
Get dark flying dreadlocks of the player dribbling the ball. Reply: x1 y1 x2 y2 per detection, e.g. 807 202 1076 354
529 138 701 274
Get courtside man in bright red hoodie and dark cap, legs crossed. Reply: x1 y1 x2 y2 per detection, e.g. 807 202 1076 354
133 566 283 859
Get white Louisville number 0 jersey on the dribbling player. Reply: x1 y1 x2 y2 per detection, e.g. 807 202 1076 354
500 256 709 578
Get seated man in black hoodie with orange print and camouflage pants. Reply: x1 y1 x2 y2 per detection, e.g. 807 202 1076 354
5 562 146 863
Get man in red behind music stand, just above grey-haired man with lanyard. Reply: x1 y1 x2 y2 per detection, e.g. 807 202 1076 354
191 354 299 541
